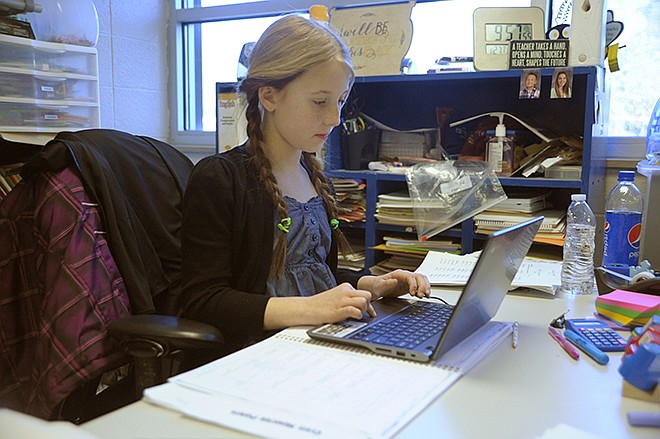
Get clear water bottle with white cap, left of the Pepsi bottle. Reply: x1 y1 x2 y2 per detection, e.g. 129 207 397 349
561 194 596 294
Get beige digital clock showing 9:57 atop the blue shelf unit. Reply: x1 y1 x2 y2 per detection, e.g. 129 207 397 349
473 7 545 70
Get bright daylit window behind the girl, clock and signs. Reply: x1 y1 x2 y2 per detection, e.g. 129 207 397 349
170 0 660 150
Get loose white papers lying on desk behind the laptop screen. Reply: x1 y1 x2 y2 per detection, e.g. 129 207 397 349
416 252 561 294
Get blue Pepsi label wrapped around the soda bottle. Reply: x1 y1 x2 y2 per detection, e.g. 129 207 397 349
603 211 642 271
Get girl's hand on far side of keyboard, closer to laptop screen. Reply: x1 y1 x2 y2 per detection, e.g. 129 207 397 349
358 270 431 300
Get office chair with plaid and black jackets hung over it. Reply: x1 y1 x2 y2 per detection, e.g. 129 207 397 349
0 130 223 423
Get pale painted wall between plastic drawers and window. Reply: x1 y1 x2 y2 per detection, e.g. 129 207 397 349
93 0 169 141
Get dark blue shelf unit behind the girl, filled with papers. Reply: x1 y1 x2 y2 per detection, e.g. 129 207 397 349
325 66 607 276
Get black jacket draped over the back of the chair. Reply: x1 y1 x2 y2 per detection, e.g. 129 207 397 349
21 129 193 314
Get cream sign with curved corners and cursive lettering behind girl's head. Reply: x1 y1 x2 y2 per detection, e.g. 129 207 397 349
330 2 414 76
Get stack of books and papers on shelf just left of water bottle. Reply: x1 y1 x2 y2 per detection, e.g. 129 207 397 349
474 192 566 246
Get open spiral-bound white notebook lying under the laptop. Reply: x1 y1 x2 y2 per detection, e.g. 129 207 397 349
144 321 511 439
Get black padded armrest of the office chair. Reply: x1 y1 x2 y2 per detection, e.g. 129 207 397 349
108 314 224 357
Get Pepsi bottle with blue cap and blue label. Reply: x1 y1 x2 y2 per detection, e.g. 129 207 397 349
603 171 644 276
